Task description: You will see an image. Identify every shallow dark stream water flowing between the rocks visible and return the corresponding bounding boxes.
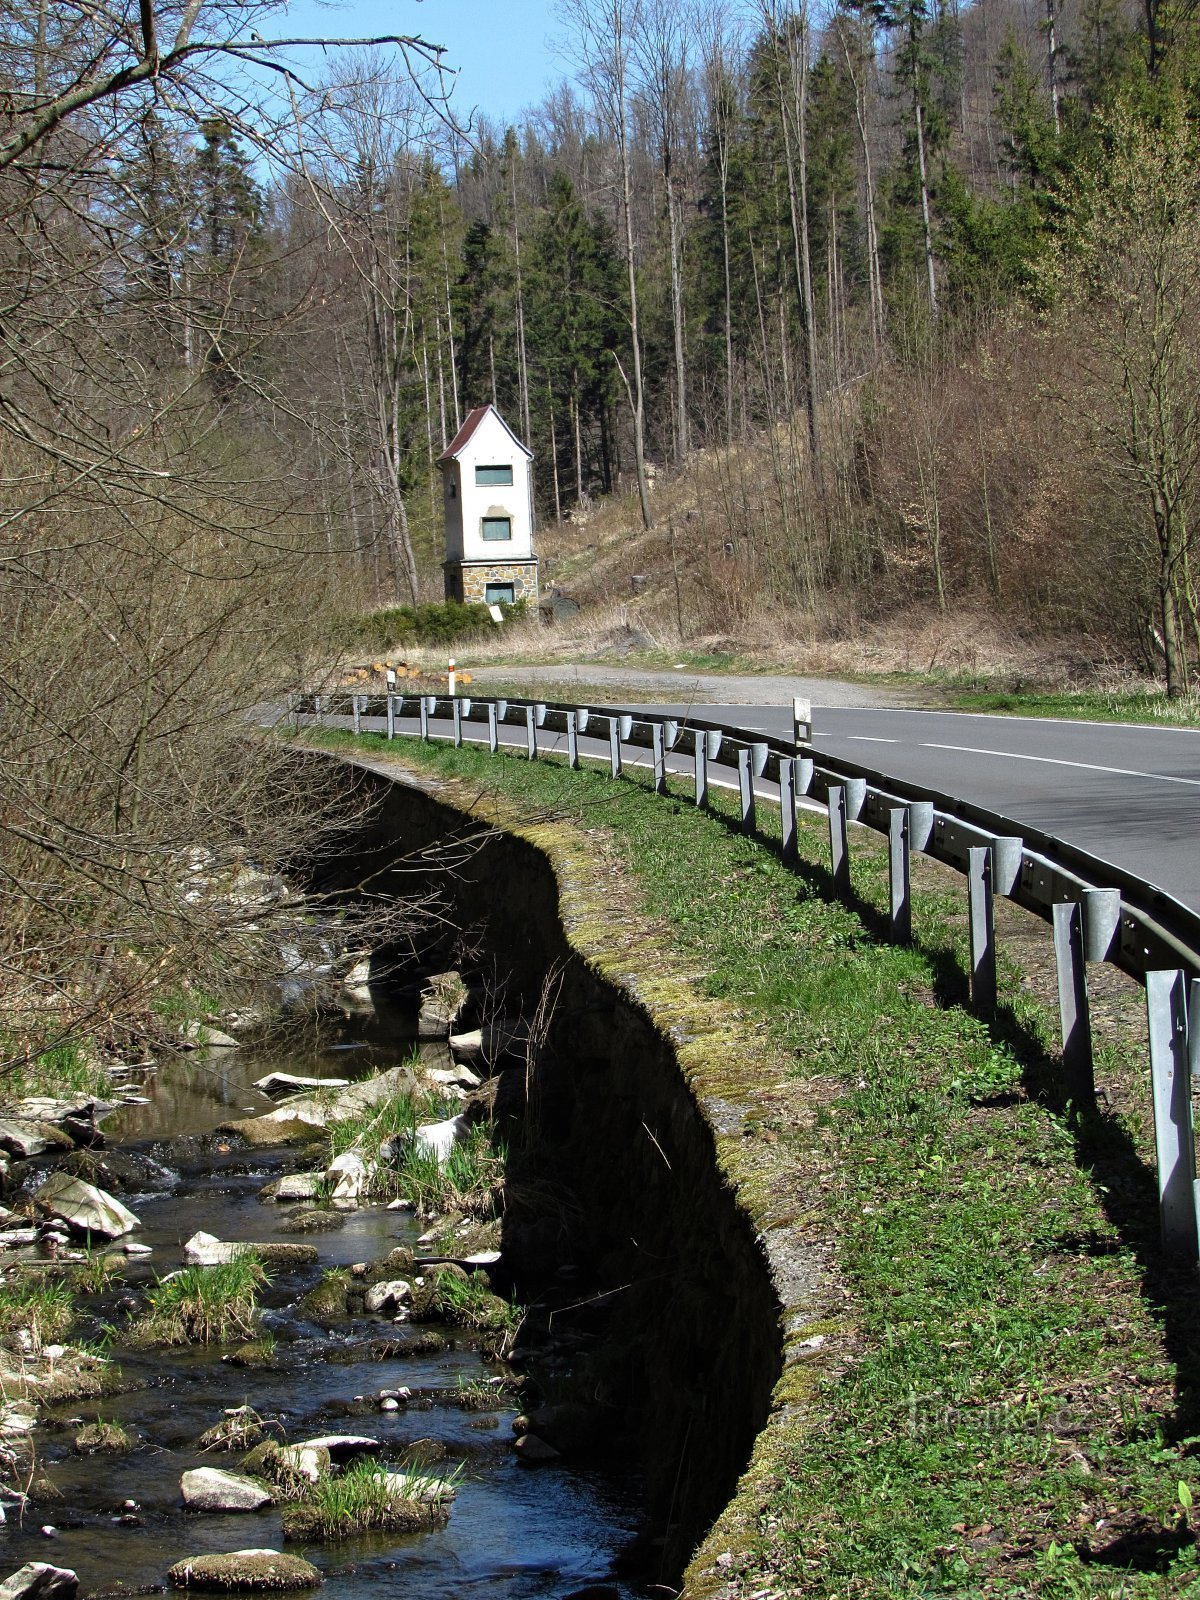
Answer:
[0,1013,649,1600]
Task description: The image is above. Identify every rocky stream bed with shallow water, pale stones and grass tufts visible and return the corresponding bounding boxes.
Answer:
[0,974,646,1600]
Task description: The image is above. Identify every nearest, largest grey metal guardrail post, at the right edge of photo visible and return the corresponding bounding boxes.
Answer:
[1146,970,1197,1261]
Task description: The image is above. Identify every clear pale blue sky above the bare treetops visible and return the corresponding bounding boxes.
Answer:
[277,0,568,123]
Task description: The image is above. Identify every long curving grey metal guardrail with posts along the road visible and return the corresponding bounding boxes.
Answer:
[290,694,1200,1261]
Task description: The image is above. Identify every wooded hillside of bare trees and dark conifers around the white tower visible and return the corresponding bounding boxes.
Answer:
[0,0,1200,1056]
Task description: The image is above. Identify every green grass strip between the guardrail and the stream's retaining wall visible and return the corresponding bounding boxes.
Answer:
[305,736,1200,1600]
